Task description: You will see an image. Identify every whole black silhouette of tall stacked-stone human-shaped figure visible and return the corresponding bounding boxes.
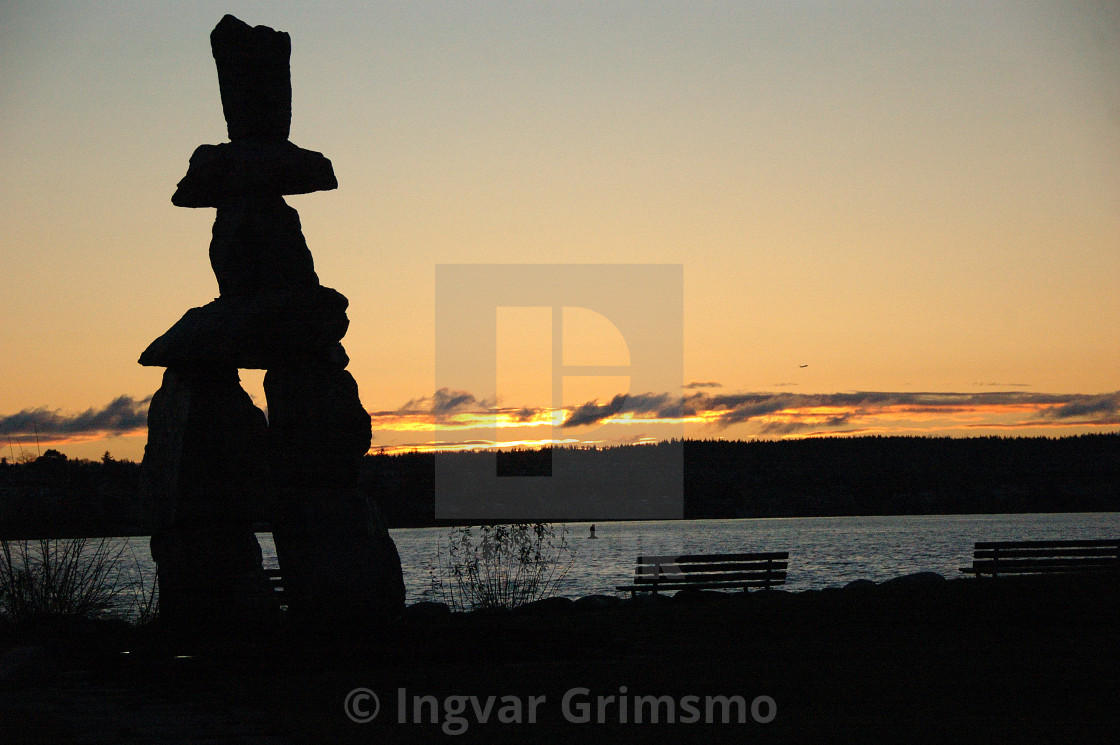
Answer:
[140,16,404,631]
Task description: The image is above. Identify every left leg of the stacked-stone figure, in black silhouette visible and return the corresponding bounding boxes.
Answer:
[141,367,280,632]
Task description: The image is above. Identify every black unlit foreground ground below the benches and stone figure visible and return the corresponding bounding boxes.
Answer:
[0,579,1120,744]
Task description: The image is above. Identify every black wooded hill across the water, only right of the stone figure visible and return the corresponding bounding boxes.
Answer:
[365,435,1120,527]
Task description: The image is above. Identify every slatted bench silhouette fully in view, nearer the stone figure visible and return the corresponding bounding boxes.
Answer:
[617,551,790,597]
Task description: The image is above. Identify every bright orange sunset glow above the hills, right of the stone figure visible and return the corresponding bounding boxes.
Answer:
[360,393,1120,453]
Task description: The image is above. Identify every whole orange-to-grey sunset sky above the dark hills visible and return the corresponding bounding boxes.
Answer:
[0,0,1120,459]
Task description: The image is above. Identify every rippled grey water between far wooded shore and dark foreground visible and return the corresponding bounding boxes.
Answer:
[115,512,1120,603]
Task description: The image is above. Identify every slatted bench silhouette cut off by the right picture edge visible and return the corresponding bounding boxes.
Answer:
[961,539,1120,577]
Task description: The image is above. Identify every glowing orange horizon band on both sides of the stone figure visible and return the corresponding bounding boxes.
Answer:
[0,391,1120,460]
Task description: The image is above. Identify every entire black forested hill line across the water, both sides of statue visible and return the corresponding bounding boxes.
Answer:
[0,435,1120,538]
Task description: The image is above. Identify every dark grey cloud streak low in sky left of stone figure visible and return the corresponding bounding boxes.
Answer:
[0,395,151,443]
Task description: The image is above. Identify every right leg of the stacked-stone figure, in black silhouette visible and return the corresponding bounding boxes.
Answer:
[264,364,404,632]
